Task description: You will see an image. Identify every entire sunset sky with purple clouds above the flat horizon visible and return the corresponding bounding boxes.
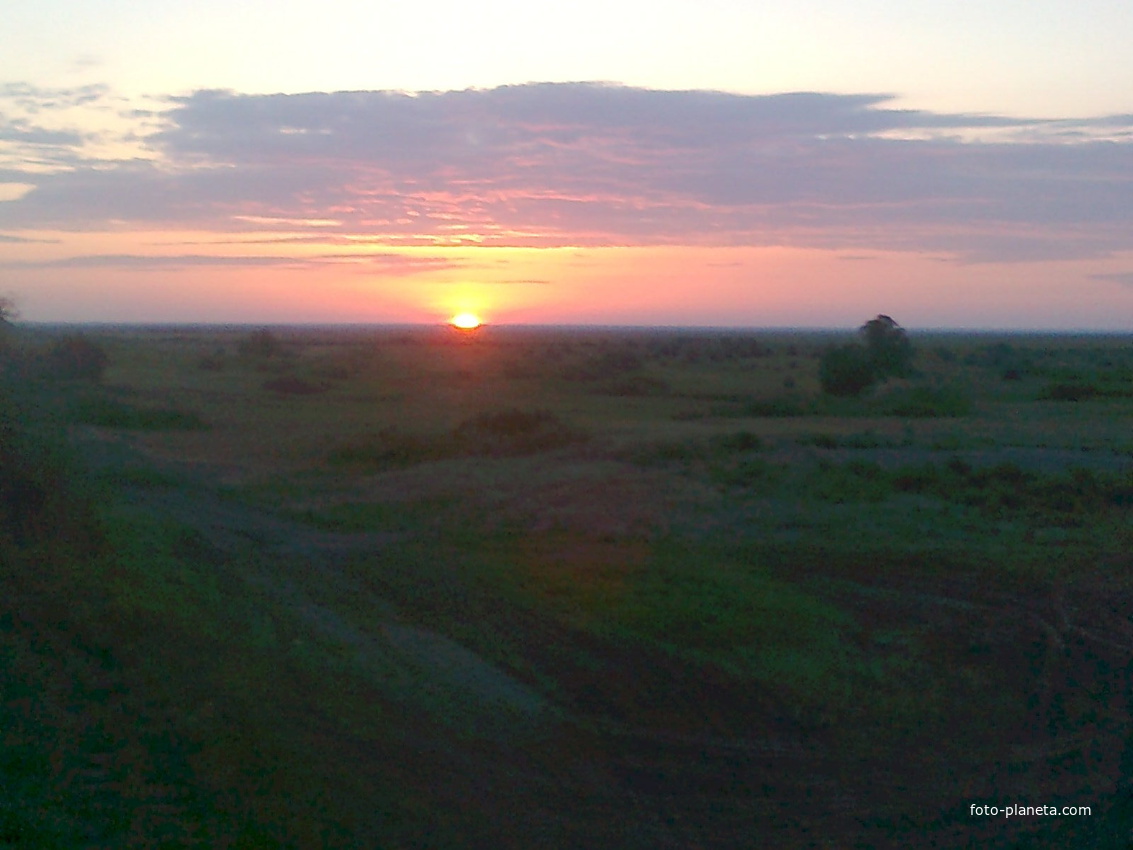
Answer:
[0,0,1133,331]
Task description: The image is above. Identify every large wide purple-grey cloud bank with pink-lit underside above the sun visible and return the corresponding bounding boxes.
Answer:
[0,83,1133,262]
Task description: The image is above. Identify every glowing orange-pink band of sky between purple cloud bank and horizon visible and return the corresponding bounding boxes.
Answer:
[8,232,1133,330]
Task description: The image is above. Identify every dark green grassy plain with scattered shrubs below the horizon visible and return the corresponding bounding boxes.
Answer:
[0,328,1133,848]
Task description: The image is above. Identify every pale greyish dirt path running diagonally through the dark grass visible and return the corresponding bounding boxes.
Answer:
[84,432,559,741]
